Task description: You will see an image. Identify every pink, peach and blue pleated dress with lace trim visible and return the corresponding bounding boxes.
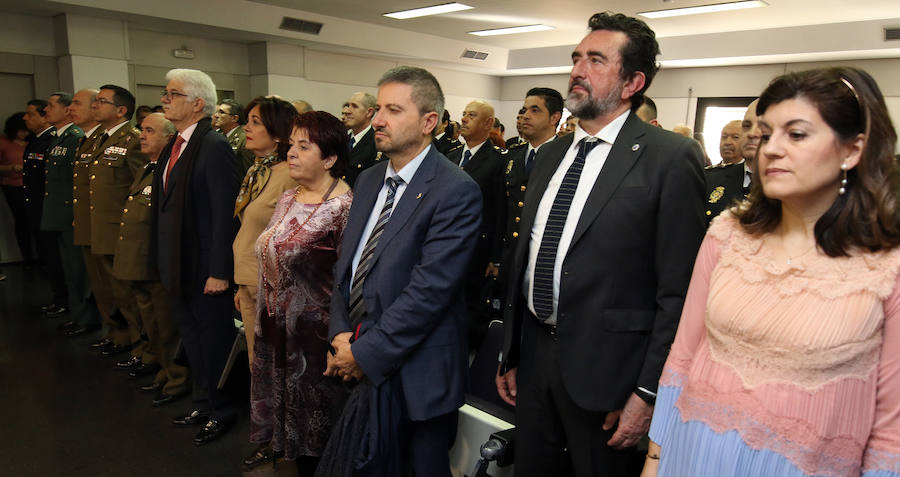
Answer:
[650,211,900,477]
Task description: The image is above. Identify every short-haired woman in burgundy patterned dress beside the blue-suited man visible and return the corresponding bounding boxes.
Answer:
[250,111,353,475]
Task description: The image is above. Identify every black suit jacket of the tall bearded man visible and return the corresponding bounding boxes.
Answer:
[501,114,705,411]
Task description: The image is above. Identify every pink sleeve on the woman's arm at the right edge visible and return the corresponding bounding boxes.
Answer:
[863,277,900,477]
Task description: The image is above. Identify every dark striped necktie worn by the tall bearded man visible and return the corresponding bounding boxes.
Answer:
[531,137,601,321]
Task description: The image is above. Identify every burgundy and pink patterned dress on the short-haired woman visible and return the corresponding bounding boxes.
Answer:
[250,190,353,460]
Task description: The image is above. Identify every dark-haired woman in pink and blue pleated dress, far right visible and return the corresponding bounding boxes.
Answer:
[644,68,900,477]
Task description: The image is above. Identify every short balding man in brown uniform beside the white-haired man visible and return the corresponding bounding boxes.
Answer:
[113,113,190,406]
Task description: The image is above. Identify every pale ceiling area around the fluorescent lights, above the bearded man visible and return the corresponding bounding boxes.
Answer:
[253,0,900,49]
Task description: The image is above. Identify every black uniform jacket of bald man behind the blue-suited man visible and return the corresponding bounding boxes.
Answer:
[447,140,506,266]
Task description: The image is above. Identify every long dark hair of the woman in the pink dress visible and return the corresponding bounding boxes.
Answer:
[738,67,900,257]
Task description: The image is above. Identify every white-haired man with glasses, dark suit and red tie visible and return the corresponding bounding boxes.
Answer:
[151,69,241,446]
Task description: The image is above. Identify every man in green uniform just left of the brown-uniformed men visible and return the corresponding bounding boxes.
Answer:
[41,92,100,330]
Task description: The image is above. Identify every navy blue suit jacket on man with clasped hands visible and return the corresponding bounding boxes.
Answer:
[329,146,481,421]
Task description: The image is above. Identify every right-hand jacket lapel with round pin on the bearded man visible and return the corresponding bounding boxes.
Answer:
[569,114,645,249]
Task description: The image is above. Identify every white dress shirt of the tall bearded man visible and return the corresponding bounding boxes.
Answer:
[522,111,630,324]
